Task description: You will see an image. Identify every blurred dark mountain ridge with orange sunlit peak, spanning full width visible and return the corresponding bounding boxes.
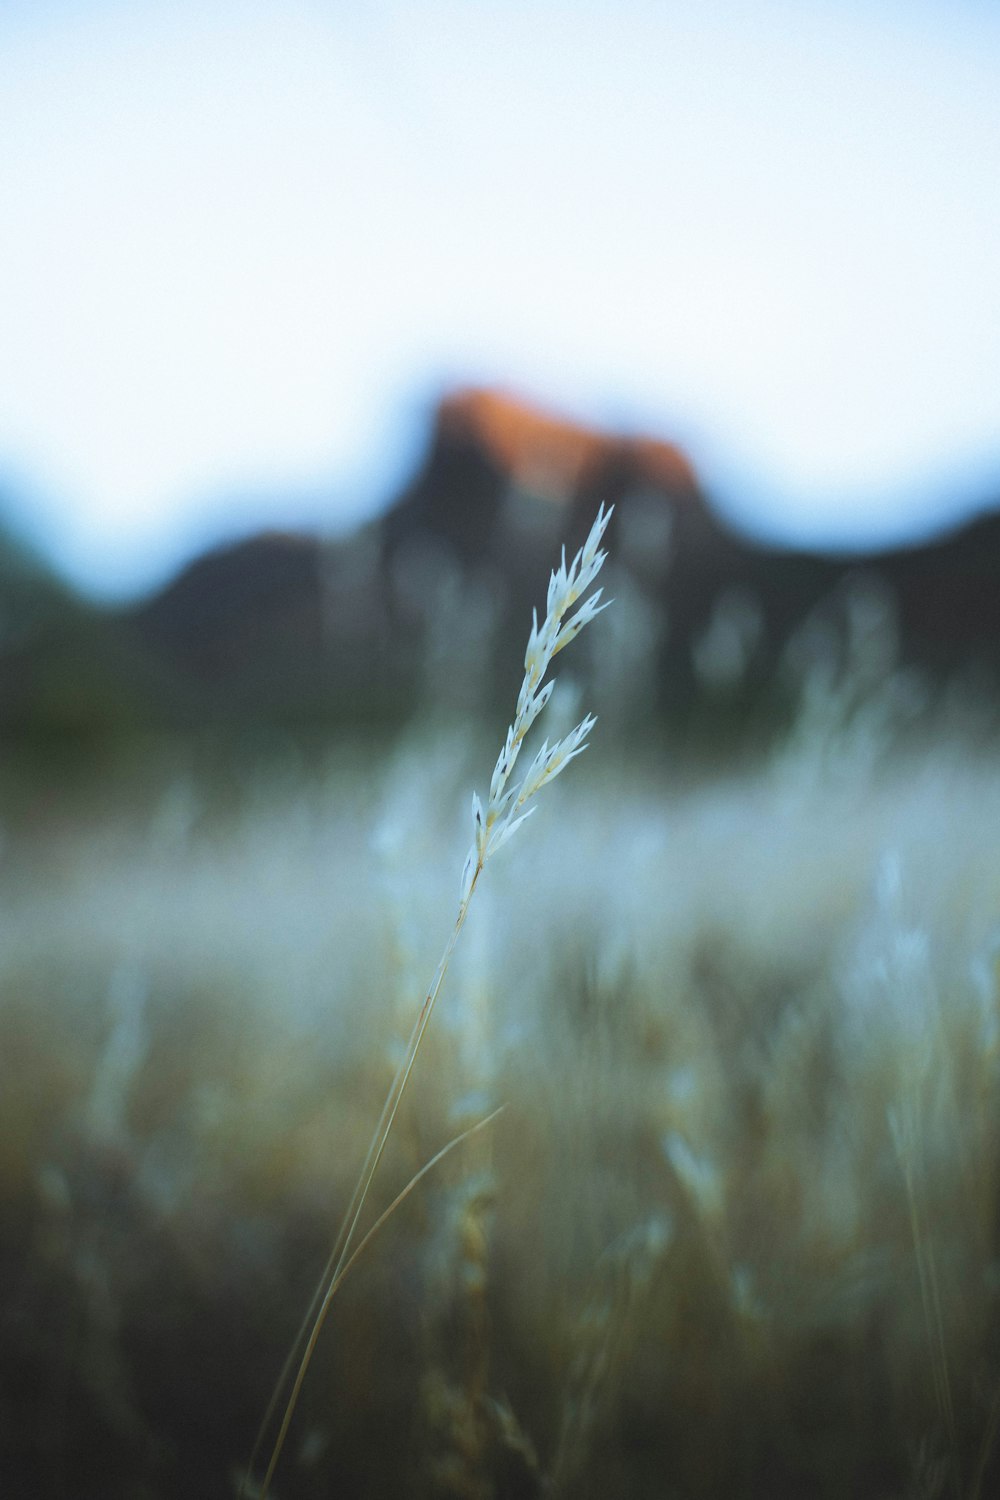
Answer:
[0,390,1000,737]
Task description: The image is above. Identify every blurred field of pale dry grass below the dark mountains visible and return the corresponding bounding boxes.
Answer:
[0,552,1000,1500]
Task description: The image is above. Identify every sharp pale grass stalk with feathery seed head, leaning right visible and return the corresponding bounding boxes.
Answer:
[241,506,615,1500]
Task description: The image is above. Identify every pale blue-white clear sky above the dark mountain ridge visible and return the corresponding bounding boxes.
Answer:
[0,0,1000,597]
